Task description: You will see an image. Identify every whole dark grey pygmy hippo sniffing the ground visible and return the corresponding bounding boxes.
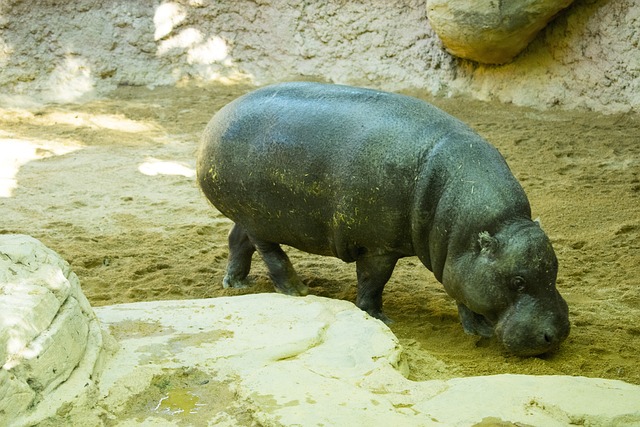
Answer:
[197,83,569,356]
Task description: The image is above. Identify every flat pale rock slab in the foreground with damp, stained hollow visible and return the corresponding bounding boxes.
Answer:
[95,294,640,426]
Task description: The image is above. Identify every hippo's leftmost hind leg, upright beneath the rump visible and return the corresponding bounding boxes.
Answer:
[222,224,256,288]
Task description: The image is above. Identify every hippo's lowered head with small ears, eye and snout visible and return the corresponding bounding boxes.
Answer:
[443,220,569,356]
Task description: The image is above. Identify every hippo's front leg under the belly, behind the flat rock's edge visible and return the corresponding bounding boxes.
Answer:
[356,256,398,324]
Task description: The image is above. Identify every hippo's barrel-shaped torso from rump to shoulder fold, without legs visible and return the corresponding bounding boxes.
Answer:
[197,83,510,261]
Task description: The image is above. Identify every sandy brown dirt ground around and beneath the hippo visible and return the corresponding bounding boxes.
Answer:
[0,85,640,384]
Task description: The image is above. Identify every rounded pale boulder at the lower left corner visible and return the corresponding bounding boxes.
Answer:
[0,235,112,425]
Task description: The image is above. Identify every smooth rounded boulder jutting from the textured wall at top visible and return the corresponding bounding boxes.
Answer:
[427,0,573,64]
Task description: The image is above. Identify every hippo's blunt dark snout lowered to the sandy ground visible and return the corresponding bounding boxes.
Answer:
[495,294,570,357]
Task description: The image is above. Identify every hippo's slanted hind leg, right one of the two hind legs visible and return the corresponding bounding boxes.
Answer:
[252,239,309,296]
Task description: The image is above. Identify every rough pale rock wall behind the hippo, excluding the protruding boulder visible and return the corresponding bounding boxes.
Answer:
[0,0,640,112]
